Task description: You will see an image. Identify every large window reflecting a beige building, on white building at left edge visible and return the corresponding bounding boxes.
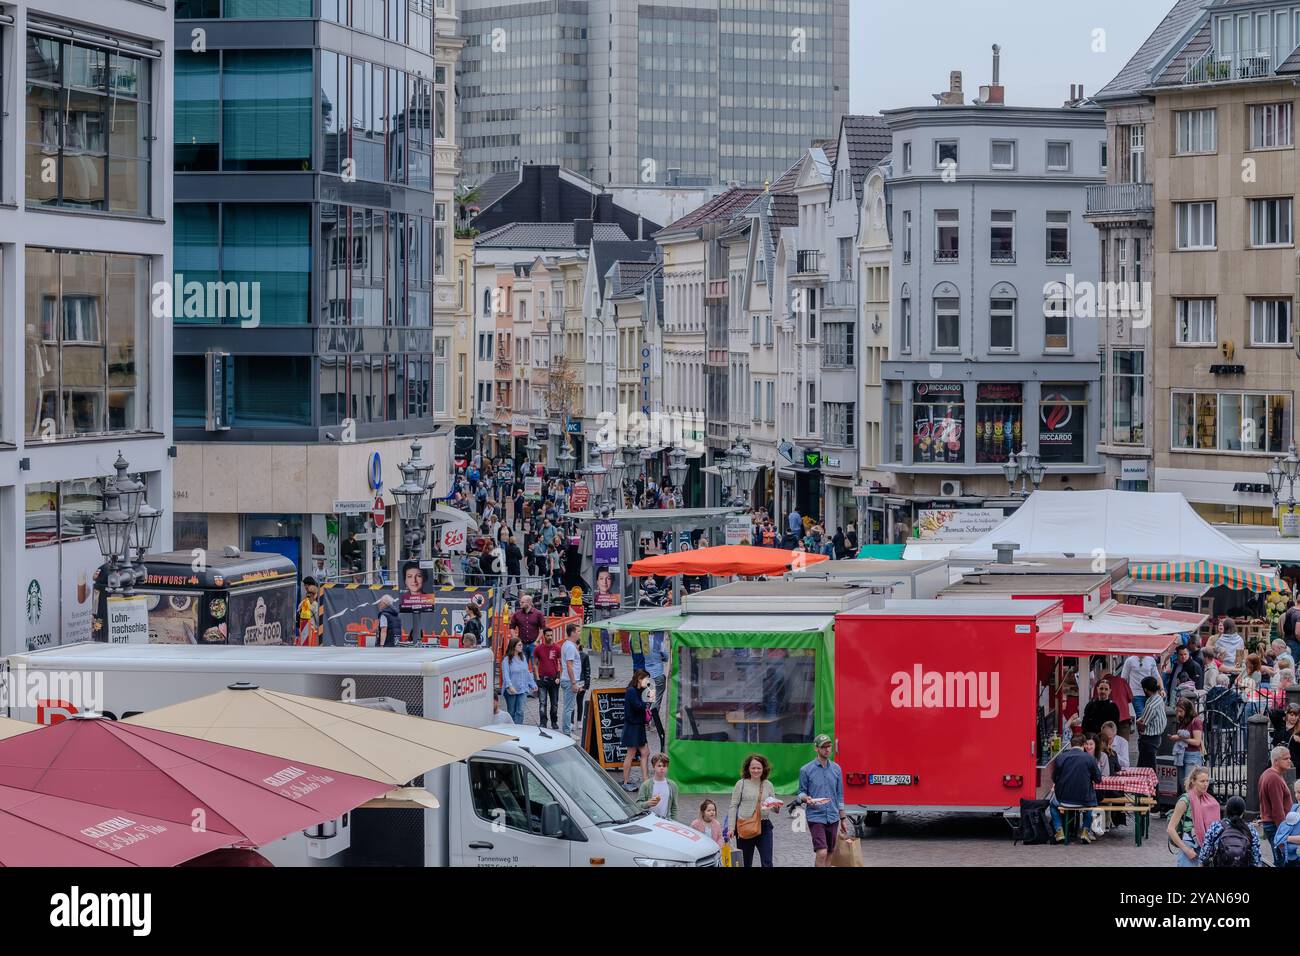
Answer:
[23,248,151,438]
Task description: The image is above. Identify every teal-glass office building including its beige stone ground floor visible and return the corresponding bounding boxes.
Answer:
[173,0,455,574]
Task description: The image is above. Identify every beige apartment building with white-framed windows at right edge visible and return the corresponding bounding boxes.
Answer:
[1145,4,1300,524]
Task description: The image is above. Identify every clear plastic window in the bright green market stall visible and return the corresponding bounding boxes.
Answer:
[676,646,816,744]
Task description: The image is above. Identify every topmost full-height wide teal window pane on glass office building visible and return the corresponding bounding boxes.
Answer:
[221,49,312,172]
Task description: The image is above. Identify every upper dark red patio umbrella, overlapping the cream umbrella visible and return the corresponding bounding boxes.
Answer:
[0,718,391,842]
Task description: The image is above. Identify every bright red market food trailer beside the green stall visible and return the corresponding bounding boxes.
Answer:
[835,597,1195,826]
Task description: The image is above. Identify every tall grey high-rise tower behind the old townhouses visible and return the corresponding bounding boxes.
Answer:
[459,0,849,186]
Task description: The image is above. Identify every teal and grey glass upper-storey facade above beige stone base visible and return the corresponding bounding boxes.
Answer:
[173,0,450,441]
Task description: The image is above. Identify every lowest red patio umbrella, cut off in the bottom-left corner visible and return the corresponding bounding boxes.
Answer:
[0,787,230,866]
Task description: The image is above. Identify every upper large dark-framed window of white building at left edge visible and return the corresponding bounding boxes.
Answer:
[25,34,153,215]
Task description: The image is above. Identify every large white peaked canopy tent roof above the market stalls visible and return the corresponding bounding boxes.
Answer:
[950,490,1260,570]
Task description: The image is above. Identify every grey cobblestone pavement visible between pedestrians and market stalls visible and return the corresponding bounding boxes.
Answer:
[512,653,1174,866]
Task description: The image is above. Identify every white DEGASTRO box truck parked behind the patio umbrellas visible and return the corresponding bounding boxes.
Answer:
[3,643,720,866]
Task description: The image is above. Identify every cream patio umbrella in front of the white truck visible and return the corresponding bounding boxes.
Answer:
[126,684,514,809]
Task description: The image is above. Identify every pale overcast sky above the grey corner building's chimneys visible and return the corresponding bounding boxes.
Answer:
[849,0,1174,113]
